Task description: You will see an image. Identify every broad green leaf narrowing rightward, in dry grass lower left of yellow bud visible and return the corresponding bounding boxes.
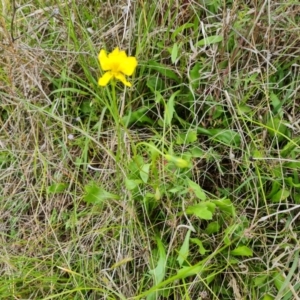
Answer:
[83,182,120,204]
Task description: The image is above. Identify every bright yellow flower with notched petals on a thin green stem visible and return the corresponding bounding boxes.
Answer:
[98,47,137,86]
